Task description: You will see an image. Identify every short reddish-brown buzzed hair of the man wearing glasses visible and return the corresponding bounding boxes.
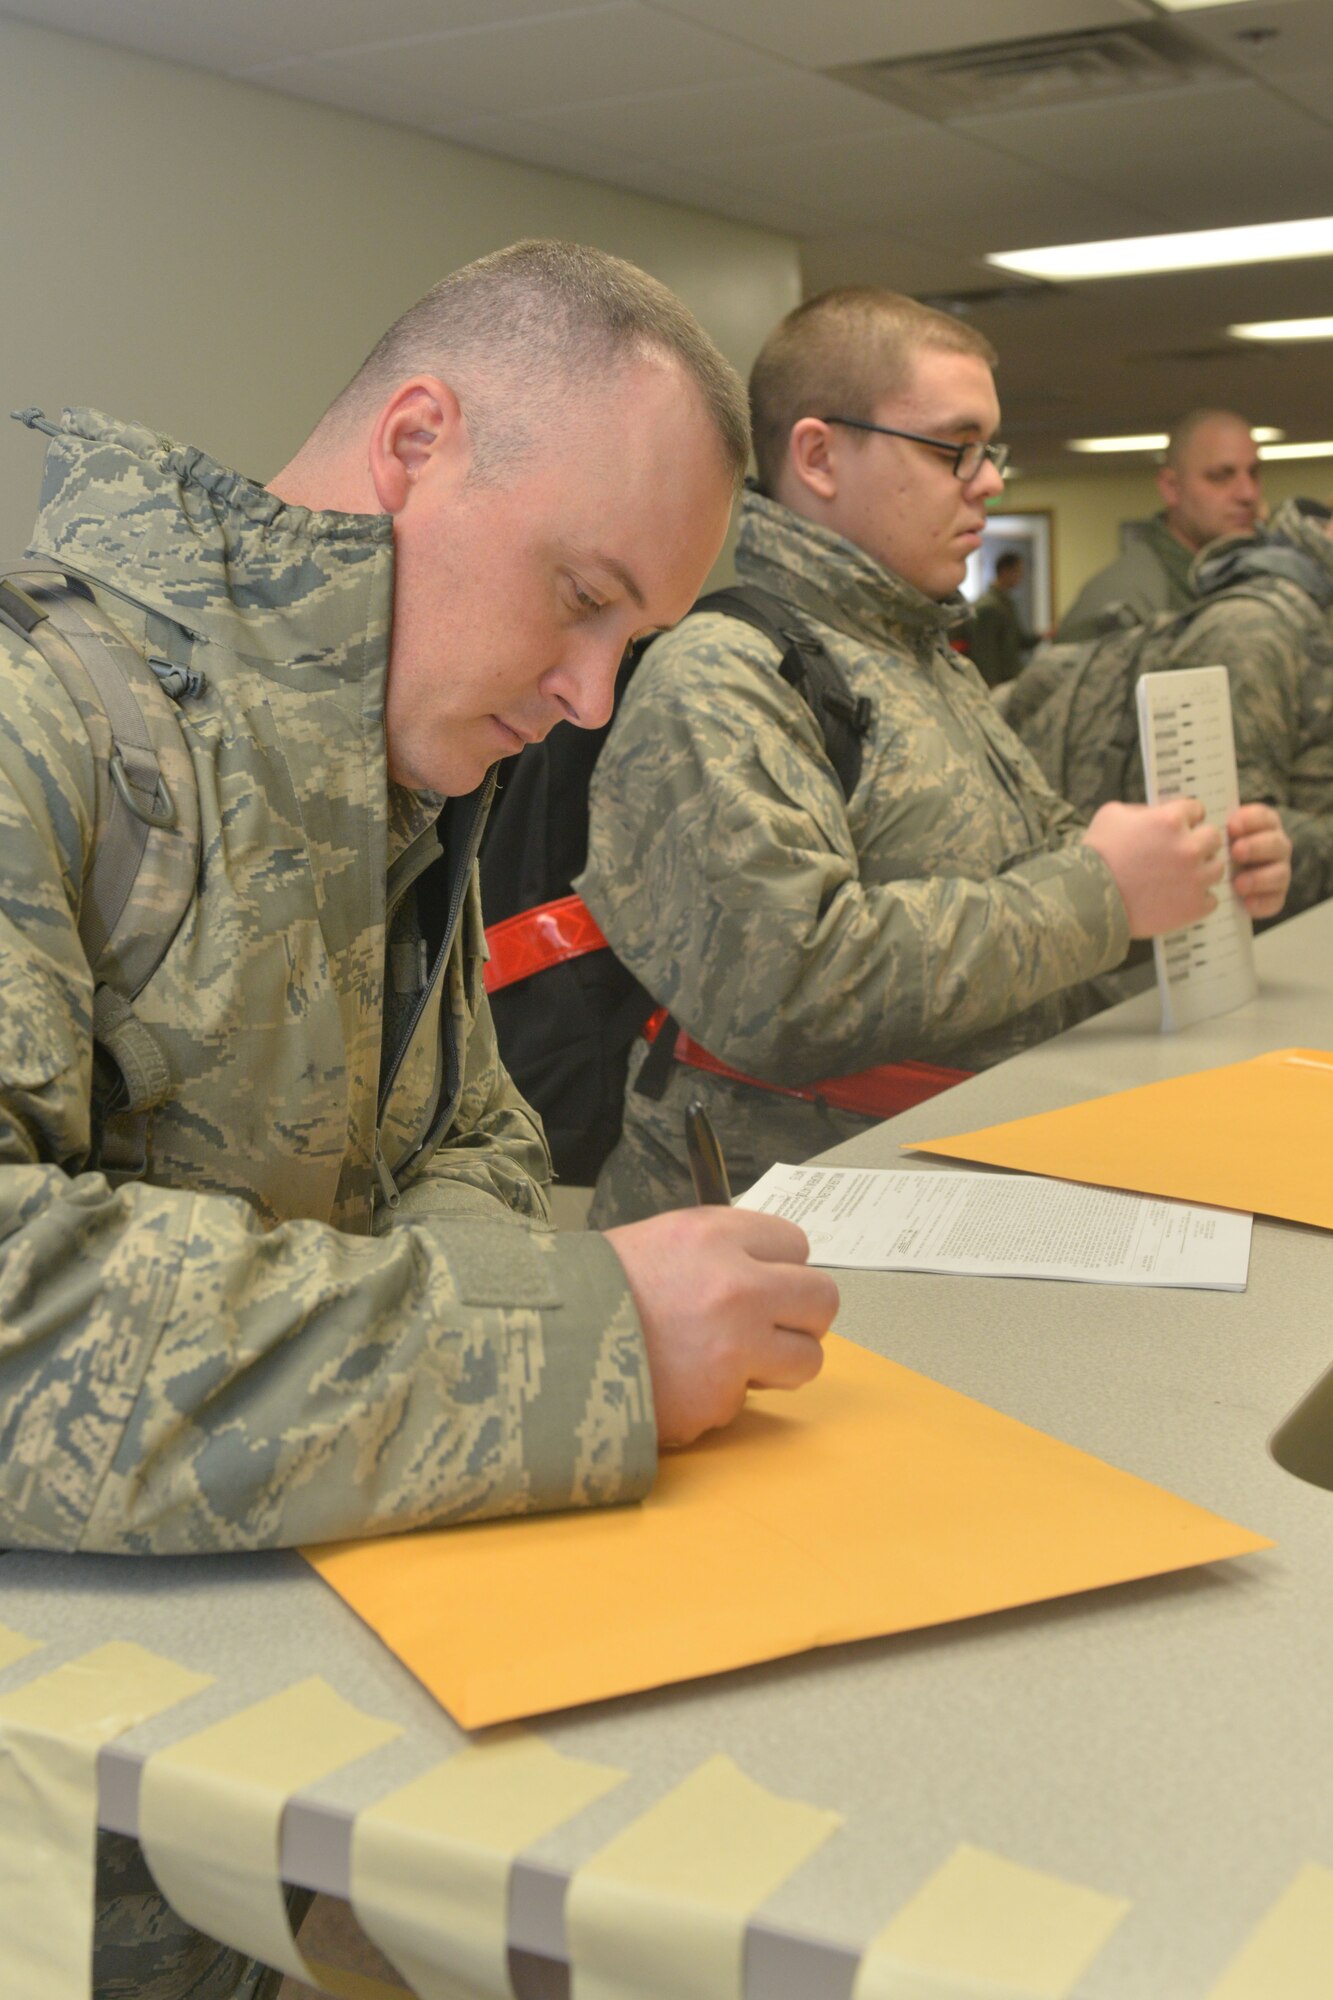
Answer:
[751,284,999,496]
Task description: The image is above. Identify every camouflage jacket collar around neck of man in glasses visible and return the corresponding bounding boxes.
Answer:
[737,486,971,648]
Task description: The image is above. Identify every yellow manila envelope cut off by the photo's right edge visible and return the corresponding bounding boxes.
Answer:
[903,1048,1333,1230]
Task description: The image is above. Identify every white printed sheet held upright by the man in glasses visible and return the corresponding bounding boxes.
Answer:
[1139,666,1259,1032]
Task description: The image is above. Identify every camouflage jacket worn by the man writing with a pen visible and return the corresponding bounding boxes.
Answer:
[0,412,654,1554]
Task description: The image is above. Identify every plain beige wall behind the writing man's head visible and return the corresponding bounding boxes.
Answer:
[0,20,801,550]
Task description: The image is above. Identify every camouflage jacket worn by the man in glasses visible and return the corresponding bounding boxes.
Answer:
[578,494,1129,1220]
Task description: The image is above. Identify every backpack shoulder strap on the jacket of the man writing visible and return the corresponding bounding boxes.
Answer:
[0,558,200,1016]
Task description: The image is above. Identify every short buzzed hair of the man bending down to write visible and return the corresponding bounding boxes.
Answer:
[320,238,751,488]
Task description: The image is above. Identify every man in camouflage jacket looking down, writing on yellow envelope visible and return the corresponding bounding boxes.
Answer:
[0,244,837,2000]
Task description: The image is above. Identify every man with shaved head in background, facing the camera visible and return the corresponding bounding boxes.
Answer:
[1055,410,1263,640]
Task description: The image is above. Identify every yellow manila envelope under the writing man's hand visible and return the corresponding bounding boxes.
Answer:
[302,1334,1271,1728]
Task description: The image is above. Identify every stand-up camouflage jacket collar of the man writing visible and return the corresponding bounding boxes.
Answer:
[20,410,392,684]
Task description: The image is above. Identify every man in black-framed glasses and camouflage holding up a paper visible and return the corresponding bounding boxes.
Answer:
[578,288,1289,1224]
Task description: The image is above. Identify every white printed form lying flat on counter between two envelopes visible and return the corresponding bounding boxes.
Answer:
[737,1166,1253,1292]
